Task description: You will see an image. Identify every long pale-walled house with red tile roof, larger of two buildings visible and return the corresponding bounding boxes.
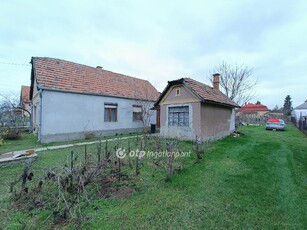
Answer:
[30,57,159,143]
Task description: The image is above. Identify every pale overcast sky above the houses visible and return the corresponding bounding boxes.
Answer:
[0,0,307,108]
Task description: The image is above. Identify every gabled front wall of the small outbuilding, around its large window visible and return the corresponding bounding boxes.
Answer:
[160,86,201,139]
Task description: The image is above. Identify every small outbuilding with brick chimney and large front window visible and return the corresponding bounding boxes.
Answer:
[155,74,239,140]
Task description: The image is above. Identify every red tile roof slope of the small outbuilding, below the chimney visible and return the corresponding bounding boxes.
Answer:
[183,78,239,107]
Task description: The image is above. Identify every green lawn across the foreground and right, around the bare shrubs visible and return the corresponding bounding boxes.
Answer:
[0,126,307,229]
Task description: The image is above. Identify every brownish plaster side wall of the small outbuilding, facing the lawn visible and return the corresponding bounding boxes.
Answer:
[201,103,235,140]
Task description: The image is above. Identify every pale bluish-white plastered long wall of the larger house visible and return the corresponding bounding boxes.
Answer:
[40,90,156,143]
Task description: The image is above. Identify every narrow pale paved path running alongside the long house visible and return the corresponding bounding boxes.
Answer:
[0,136,142,164]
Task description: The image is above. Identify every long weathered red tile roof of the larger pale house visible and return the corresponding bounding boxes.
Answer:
[32,57,160,101]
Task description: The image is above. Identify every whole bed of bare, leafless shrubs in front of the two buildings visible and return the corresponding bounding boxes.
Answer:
[10,135,201,225]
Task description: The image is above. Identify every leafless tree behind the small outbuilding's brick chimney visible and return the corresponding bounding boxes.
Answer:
[210,61,258,105]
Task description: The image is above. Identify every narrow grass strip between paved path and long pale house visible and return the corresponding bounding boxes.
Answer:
[0,133,144,154]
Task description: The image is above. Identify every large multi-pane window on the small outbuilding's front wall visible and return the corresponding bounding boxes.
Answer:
[168,106,189,127]
